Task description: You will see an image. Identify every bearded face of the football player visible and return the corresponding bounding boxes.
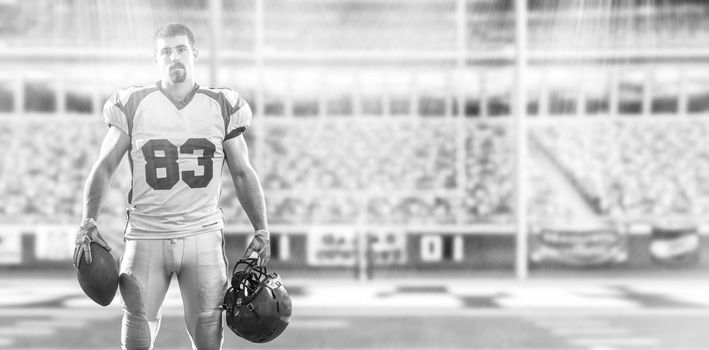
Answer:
[155,35,197,84]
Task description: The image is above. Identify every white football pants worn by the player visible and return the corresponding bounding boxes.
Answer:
[119,230,228,350]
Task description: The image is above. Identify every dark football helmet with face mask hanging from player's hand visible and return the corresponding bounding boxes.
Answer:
[222,259,293,343]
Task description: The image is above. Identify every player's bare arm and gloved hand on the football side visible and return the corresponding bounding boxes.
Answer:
[74,126,130,267]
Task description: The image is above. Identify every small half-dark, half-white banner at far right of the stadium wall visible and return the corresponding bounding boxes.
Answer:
[649,226,700,266]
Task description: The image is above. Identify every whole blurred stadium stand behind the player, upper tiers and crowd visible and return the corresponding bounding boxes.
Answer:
[0,0,709,274]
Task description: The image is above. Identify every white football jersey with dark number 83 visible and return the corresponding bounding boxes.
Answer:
[103,82,251,239]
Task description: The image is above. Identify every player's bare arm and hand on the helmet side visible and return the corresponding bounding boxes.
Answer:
[222,135,271,266]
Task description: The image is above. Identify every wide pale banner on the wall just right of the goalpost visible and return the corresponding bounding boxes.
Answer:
[530,228,628,266]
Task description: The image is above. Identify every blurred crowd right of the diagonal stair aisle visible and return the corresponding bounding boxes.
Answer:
[534,119,709,220]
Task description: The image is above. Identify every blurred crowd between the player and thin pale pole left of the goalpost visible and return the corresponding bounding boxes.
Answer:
[231,118,459,224]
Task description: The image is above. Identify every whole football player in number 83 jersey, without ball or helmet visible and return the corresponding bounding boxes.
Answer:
[74,24,270,349]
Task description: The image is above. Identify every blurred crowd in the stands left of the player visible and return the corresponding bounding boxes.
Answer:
[0,121,126,223]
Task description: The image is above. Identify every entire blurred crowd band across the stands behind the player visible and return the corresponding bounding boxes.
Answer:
[0,118,709,225]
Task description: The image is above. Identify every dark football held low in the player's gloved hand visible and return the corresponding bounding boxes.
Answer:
[76,242,118,306]
